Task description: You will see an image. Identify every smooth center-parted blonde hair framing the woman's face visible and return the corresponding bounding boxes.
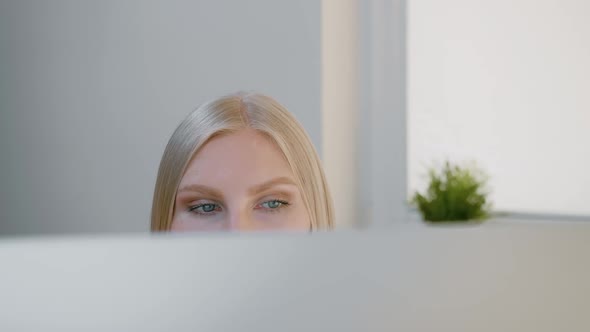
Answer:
[151,93,334,231]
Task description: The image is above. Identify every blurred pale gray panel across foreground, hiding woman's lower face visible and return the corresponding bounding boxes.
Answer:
[0,223,590,332]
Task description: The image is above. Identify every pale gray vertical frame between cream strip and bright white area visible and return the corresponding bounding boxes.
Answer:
[358,0,411,227]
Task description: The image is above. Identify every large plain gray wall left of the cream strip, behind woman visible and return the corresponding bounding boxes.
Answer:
[0,0,321,235]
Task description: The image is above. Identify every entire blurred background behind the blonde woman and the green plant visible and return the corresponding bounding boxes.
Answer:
[0,0,590,236]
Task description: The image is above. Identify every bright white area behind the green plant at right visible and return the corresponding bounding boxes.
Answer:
[408,0,590,215]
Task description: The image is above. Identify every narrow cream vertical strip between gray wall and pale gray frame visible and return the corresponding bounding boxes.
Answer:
[321,0,359,227]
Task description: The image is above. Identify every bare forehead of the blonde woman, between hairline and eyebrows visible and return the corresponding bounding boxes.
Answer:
[180,129,293,188]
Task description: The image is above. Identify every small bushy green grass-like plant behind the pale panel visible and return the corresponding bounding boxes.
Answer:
[411,161,491,222]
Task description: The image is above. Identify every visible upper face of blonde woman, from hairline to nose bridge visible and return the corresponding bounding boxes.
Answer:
[172,129,310,231]
